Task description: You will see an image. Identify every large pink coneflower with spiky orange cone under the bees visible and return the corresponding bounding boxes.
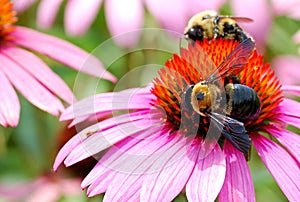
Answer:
[54,39,300,201]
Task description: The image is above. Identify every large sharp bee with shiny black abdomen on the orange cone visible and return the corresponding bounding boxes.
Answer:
[183,39,261,153]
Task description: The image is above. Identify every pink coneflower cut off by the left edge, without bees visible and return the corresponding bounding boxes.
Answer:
[0,0,115,127]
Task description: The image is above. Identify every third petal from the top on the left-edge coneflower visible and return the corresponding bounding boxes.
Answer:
[0,52,64,116]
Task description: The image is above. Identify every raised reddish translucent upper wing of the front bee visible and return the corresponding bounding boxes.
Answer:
[206,38,255,82]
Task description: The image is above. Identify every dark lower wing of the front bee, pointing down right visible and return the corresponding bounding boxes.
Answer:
[210,112,251,153]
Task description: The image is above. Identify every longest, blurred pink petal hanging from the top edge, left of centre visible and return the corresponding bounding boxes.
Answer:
[105,0,144,47]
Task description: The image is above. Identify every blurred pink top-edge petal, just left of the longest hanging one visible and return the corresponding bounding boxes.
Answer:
[65,0,102,35]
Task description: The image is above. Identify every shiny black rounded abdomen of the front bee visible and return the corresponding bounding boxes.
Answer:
[226,84,261,121]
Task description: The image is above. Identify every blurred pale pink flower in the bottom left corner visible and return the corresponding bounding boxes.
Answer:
[0,176,81,202]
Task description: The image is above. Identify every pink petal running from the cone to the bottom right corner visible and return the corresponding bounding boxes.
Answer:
[251,134,300,201]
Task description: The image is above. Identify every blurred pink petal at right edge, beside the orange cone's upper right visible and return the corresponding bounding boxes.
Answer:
[272,55,300,85]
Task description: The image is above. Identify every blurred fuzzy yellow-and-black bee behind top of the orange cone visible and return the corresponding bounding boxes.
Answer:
[184,10,253,42]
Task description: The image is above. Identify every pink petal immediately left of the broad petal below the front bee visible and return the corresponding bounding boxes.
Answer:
[141,137,200,201]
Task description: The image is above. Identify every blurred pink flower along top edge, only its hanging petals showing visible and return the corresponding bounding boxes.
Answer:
[15,0,226,47]
